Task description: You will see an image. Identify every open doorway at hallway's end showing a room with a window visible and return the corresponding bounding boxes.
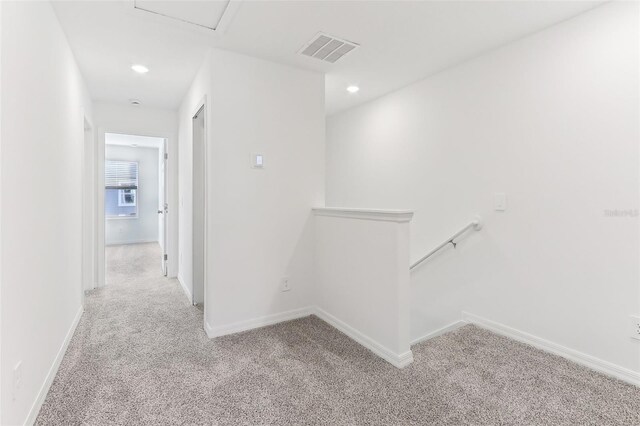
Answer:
[104,133,168,285]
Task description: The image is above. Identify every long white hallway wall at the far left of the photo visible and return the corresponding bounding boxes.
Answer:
[0,2,91,425]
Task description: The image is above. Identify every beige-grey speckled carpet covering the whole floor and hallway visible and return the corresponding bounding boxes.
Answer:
[37,244,640,425]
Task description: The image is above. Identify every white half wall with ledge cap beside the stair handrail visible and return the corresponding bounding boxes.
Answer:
[314,208,413,367]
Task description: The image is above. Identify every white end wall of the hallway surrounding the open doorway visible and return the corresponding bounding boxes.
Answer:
[93,102,178,285]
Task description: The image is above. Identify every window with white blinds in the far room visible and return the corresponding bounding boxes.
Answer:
[104,160,138,218]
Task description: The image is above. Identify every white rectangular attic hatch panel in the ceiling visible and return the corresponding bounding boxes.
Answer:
[133,0,239,31]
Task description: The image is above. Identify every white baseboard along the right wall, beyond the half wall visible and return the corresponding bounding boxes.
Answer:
[462,312,640,386]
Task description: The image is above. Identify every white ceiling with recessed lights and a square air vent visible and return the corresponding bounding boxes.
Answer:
[54,0,602,114]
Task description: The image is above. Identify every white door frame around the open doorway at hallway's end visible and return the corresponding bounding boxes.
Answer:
[96,126,178,288]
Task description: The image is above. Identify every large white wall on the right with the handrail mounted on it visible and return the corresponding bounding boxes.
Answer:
[327,3,640,372]
